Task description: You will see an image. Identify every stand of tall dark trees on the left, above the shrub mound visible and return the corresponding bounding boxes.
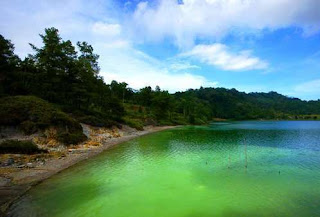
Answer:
[0,28,124,125]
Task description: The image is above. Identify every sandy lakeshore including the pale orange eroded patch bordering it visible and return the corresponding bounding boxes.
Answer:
[0,125,173,216]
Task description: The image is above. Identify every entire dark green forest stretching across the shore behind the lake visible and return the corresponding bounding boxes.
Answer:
[0,28,320,142]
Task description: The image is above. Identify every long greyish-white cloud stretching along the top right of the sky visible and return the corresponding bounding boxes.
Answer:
[132,0,320,47]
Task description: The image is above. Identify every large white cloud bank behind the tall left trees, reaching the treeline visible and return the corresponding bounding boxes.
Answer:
[0,0,216,92]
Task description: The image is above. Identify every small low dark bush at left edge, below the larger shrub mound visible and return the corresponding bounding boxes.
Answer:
[0,140,47,154]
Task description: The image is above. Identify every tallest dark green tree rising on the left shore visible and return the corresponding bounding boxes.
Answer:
[30,28,78,103]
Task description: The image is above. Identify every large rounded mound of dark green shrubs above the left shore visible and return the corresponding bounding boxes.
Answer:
[0,96,84,144]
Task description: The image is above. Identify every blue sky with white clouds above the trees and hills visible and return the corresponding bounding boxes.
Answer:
[0,0,320,100]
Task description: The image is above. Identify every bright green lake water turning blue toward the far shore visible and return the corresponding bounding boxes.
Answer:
[9,121,320,217]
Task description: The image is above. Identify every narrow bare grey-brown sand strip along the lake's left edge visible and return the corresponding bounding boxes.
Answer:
[0,126,174,216]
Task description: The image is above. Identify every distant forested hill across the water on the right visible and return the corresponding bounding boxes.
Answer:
[175,88,320,119]
